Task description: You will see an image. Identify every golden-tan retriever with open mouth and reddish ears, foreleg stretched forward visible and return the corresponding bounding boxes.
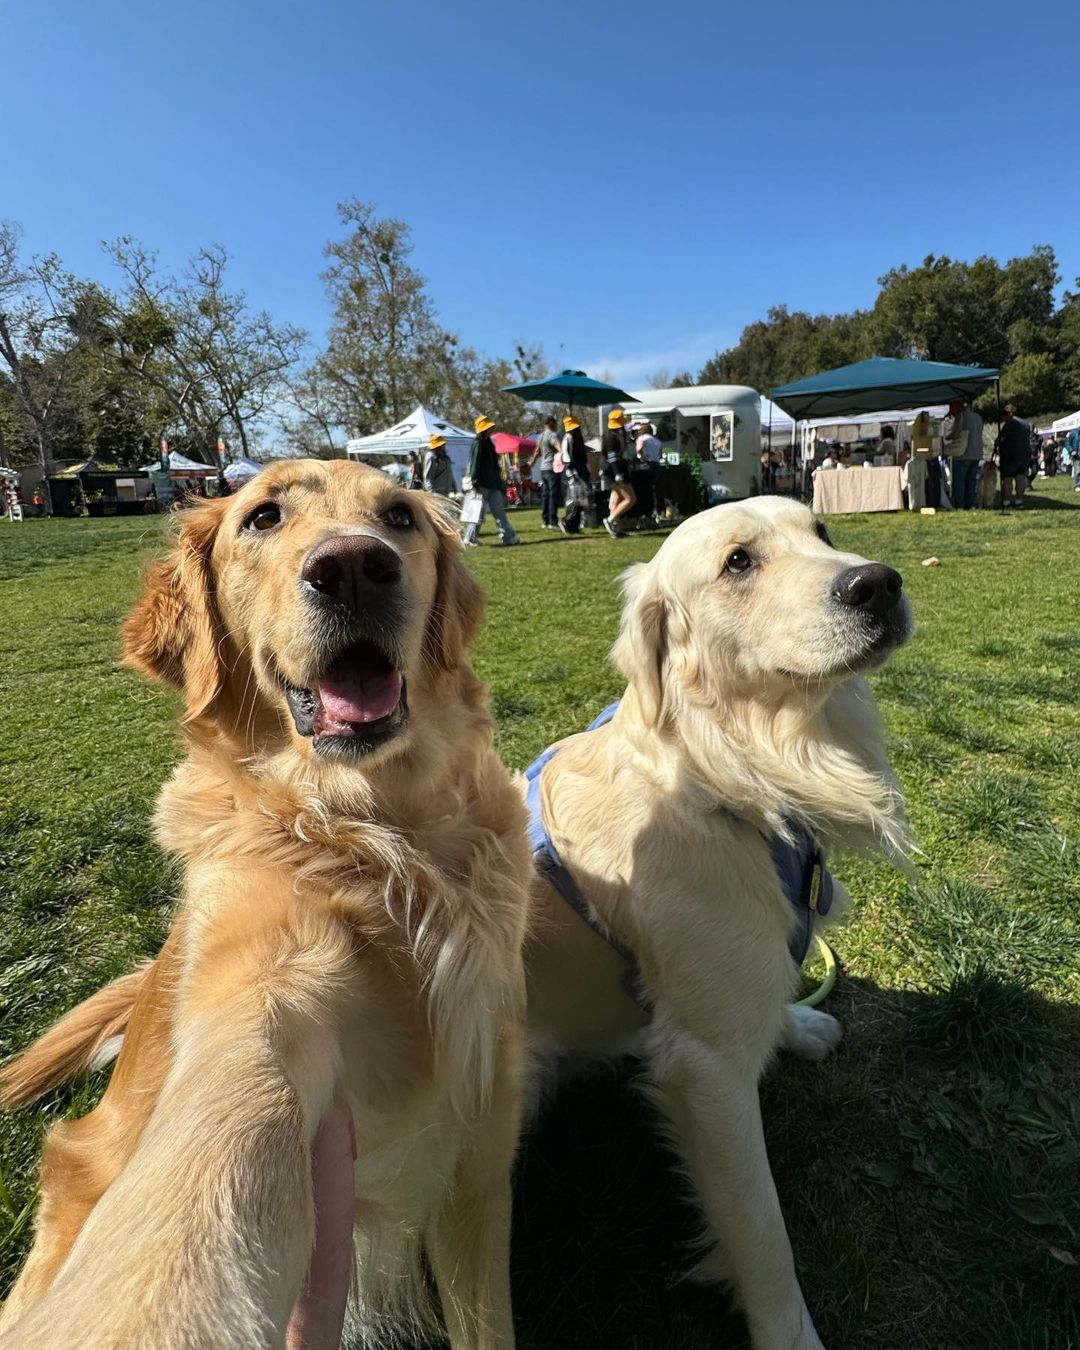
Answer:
[0,460,528,1350]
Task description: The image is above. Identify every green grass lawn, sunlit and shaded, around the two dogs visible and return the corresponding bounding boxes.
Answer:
[0,479,1080,1350]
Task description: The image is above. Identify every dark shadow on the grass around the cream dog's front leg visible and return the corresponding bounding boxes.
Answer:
[480,968,1080,1350]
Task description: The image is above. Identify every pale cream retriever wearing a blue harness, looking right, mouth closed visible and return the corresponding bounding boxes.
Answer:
[527,497,911,1350]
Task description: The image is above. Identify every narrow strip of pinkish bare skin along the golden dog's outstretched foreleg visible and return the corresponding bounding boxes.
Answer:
[285,1098,356,1350]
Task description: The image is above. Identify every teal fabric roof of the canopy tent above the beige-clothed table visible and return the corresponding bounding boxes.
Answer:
[770,356,999,419]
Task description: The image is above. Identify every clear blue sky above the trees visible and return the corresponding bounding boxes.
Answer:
[0,0,1080,385]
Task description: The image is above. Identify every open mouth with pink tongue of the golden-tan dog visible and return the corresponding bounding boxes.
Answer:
[284,641,408,753]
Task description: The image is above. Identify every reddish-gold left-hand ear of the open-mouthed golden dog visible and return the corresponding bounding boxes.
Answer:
[123,502,225,721]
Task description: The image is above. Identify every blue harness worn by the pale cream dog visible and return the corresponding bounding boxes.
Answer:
[525,702,833,1007]
